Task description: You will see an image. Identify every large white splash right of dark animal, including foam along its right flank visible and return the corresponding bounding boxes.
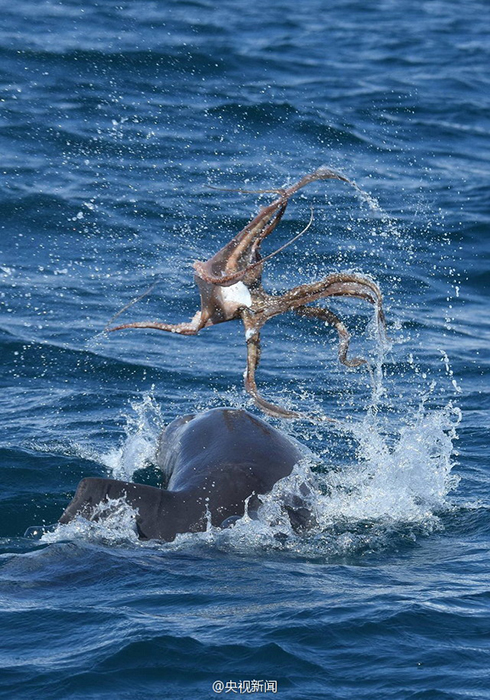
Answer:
[197,396,461,556]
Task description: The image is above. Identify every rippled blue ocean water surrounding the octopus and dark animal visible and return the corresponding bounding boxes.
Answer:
[0,0,490,700]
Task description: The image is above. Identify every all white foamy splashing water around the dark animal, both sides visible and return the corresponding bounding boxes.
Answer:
[41,382,461,557]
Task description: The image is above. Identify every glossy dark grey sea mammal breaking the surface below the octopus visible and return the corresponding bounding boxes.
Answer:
[59,408,308,542]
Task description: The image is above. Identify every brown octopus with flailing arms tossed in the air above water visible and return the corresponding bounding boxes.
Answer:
[106,167,385,420]
